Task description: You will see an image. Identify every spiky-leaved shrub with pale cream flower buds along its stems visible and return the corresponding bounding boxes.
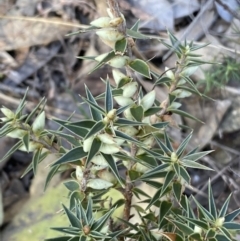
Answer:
[0,0,240,241]
